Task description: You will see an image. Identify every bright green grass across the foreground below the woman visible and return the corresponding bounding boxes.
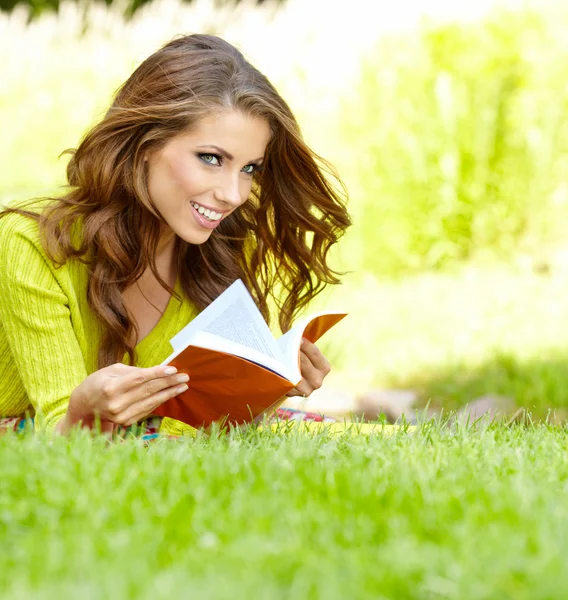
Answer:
[0,424,568,600]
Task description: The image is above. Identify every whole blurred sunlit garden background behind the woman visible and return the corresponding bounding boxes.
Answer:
[0,0,568,411]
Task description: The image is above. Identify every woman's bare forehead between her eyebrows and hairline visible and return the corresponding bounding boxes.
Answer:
[175,110,270,161]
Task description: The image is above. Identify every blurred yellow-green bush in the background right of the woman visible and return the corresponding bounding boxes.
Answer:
[341,10,568,273]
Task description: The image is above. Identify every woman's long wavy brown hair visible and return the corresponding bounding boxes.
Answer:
[3,35,350,368]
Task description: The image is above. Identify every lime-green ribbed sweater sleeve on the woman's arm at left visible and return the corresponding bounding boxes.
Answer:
[0,215,87,430]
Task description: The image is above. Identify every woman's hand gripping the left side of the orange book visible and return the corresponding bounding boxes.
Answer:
[56,363,189,433]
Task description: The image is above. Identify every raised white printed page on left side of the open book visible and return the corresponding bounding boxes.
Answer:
[167,279,283,360]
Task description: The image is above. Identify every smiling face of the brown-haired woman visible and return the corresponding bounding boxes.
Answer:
[147,110,270,244]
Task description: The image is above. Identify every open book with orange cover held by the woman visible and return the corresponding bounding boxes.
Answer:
[153,279,346,427]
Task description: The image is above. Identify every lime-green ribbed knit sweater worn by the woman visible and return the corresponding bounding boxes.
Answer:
[0,209,196,433]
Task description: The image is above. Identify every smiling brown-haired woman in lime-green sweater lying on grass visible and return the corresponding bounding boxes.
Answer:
[0,35,350,434]
